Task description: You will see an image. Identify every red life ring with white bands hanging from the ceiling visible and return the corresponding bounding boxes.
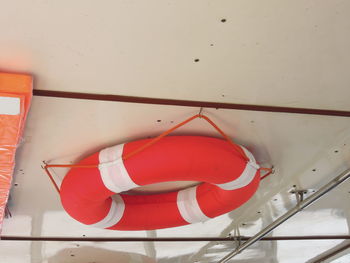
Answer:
[60,136,260,230]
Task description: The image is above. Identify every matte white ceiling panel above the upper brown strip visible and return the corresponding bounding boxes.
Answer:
[0,0,350,110]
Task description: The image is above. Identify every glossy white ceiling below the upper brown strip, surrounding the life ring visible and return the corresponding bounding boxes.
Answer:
[0,97,350,263]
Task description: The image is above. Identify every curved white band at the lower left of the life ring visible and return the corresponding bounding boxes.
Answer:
[89,195,125,228]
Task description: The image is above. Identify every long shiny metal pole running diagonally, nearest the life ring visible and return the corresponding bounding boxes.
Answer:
[219,170,350,263]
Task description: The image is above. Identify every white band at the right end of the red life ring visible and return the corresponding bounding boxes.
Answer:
[216,146,260,190]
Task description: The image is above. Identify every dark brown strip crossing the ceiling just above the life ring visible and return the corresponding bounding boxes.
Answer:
[33,90,350,117]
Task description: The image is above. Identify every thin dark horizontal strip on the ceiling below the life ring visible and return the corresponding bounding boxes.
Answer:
[0,235,350,242]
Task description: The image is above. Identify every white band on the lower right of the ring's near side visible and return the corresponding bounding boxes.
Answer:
[177,186,210,224]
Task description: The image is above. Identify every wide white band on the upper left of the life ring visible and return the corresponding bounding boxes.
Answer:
[98,144,139,193]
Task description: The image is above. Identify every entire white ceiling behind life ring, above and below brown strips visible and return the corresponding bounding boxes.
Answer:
[0,0,350,263]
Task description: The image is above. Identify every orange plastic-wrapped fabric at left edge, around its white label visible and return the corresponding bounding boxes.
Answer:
[0,73,33,231]
